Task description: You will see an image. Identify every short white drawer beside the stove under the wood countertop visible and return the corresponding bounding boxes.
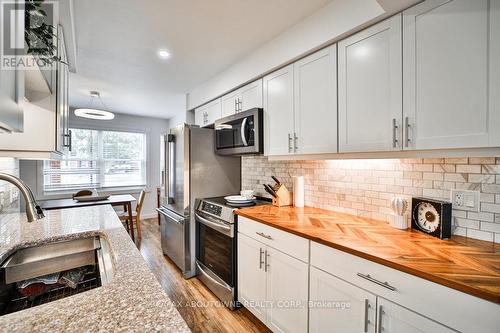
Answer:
[238,216,309,262]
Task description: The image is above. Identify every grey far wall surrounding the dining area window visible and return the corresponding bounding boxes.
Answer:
[20,110,169,218]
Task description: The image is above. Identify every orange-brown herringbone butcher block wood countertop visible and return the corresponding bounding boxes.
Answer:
[236,205,500,304]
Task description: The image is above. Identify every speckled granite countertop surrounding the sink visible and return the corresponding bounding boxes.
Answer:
[0,206,190,332]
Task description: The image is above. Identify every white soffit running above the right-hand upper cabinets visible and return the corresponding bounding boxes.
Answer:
[187,0,419,109]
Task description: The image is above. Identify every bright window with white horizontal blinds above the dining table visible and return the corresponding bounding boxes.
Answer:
[43,128,146,192]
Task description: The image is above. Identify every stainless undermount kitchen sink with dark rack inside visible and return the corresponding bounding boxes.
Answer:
[0,237,114,315]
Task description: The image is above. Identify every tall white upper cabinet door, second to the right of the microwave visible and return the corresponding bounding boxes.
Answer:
[294,45,337,154]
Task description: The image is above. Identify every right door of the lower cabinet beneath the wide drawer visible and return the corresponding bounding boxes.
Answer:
[377,297,456,333]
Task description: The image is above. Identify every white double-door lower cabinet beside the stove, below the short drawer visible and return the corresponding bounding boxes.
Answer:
[238,233,309,332]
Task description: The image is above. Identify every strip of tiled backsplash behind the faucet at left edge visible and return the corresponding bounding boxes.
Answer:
[0,157,19,215]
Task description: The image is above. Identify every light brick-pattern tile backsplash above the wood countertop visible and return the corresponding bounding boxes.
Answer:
[242,157,500,243]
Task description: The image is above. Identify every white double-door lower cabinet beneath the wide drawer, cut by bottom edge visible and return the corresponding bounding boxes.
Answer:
[309,266,455,333]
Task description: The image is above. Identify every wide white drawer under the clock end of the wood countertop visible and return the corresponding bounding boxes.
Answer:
[311,242,500,332]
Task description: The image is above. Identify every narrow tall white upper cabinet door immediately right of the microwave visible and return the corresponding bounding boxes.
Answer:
[263,65,294,155]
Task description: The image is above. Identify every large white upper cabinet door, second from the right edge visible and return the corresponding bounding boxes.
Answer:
[338,15,402,152]
